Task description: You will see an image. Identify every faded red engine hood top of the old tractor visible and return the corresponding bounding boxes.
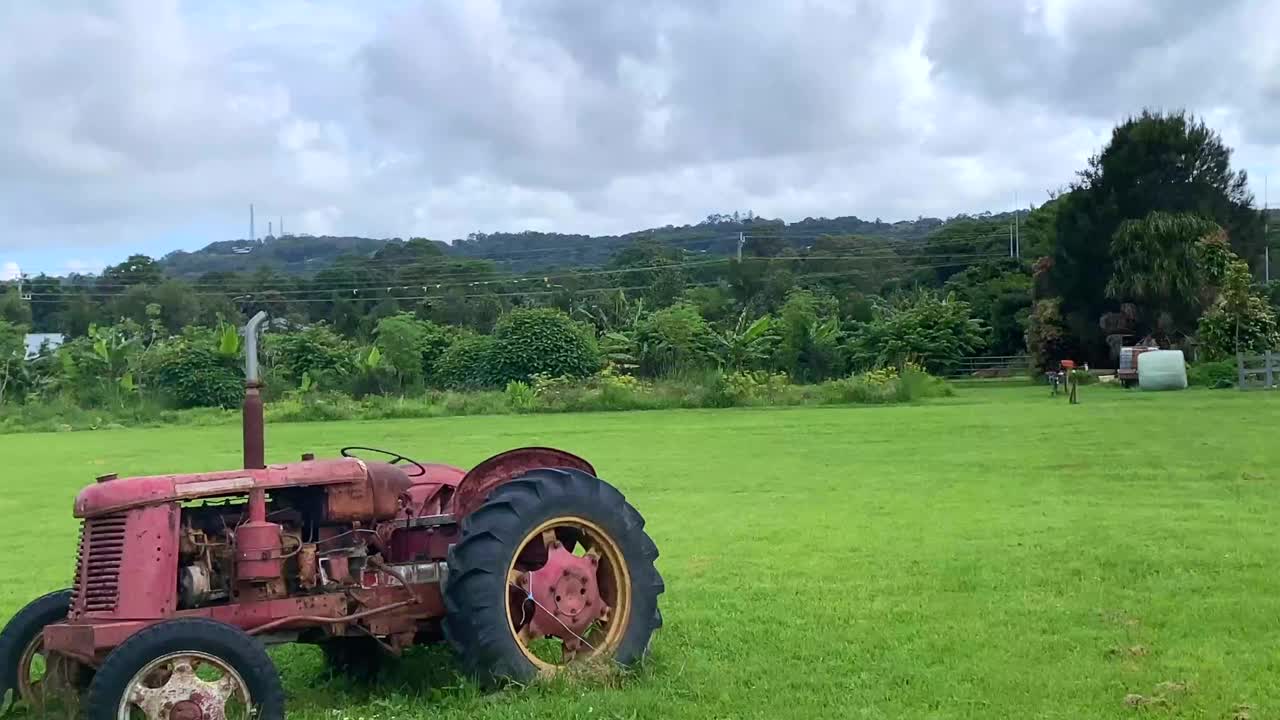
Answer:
[74,457,369,518]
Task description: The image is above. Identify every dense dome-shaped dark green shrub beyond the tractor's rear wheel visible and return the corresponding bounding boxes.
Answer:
[488,307,600,386]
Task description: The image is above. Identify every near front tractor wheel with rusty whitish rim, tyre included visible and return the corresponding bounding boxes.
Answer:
[84,618,284,720]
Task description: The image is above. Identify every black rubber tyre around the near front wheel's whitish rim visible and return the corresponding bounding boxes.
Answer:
[84,618,284,720]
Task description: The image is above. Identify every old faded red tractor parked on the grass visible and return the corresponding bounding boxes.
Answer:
[0,313,663,720]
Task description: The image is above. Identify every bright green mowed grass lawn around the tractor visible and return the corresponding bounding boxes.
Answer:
[0,387,1280,720]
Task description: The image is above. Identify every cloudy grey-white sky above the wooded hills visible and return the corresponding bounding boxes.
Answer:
[0,0,1280,273]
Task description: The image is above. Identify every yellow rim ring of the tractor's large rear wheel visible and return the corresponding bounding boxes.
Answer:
[507,515,631,674]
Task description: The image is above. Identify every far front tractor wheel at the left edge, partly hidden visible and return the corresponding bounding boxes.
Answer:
[0,591,88,710]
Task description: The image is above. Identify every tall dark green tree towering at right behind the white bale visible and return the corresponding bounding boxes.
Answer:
[1048,111,1262,364]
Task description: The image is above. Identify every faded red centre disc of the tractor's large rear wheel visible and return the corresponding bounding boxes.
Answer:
[525,543,608,650]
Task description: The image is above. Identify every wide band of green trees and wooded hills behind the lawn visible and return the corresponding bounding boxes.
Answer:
[0,111,1280,422]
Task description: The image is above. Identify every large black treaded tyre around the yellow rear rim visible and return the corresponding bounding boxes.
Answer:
[443,469,664,688]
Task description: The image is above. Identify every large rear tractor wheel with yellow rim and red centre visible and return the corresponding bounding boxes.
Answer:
[443,469,663,687]
